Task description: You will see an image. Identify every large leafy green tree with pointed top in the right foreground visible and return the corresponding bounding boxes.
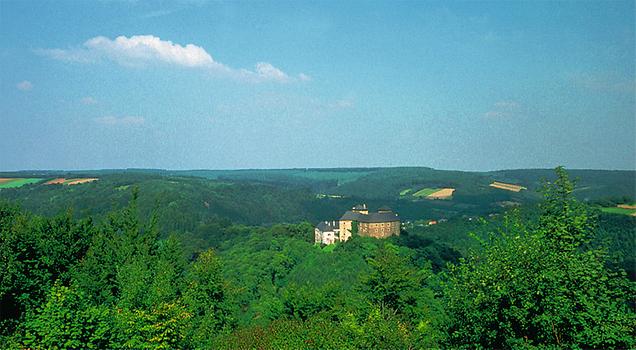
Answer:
[444,168,636,348]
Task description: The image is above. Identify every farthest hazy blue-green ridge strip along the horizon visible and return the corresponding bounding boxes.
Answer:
[22,167,636,199]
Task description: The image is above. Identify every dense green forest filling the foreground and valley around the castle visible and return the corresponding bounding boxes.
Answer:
[0,168,636,349]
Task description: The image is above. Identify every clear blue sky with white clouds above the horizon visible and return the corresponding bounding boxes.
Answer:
[0,0,636,170]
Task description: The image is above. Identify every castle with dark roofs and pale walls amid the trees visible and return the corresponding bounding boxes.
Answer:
[314,204,400,244]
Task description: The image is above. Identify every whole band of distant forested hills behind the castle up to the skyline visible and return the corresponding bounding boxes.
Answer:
[0,168,636,230]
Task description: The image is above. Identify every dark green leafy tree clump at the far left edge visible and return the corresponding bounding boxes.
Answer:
[0,203,93,330]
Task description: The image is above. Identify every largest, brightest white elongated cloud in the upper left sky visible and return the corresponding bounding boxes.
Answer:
[36,35,310,83]
